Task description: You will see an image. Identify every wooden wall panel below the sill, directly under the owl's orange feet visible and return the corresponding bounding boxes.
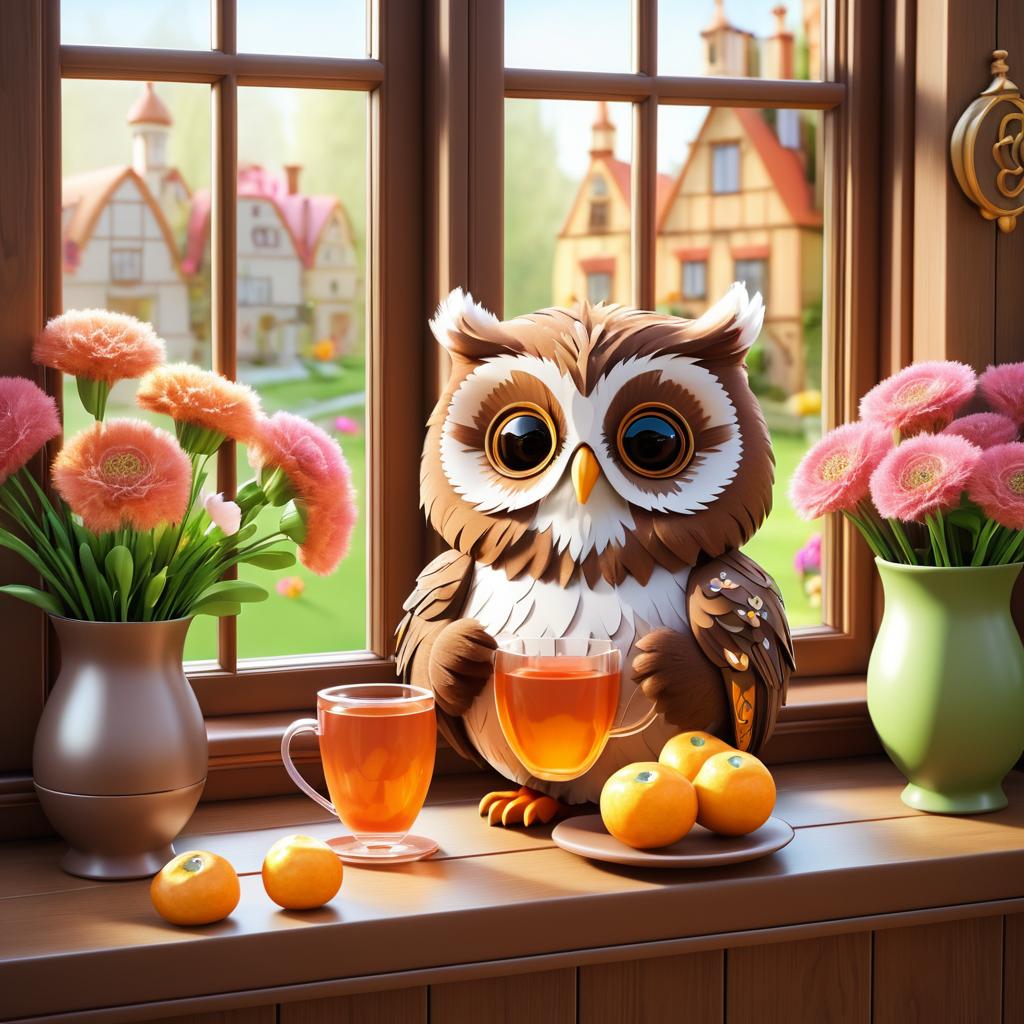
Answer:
[430,968,577,1024]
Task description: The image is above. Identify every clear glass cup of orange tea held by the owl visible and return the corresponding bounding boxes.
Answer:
[495,637,657,782]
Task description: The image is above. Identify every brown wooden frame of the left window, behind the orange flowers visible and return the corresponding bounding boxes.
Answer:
[34,0,427,717]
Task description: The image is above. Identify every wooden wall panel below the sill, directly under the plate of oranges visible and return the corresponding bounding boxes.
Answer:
[579,950,724,1024]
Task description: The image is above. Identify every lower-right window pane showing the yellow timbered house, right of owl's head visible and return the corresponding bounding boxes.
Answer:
[655,106,822,626]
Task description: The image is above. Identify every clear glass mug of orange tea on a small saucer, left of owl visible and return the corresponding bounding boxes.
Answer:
[281,683,437,864]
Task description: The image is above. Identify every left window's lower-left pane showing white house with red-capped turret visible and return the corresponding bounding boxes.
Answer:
[60,79,217,659]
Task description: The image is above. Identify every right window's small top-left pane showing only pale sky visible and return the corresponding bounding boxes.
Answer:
[505,0,633,72]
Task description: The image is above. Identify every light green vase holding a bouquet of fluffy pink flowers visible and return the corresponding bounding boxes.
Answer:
[791,362,1024,813]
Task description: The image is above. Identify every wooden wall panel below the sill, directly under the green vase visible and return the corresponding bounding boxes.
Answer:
[872,918,999,1024]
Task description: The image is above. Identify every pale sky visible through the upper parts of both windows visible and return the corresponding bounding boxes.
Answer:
[60,0,815,177]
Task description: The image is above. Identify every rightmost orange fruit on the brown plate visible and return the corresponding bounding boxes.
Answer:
[693,751,775,836]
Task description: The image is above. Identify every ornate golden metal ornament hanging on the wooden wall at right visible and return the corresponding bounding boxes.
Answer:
[949,50,1024,233]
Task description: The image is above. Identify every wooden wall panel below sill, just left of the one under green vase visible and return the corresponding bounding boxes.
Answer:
[725,932,871,1024]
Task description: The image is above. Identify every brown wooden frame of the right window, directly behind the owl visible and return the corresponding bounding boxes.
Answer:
[427,0,887,696]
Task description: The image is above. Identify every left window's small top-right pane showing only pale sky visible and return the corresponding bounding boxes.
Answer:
[238,0,368,57]
